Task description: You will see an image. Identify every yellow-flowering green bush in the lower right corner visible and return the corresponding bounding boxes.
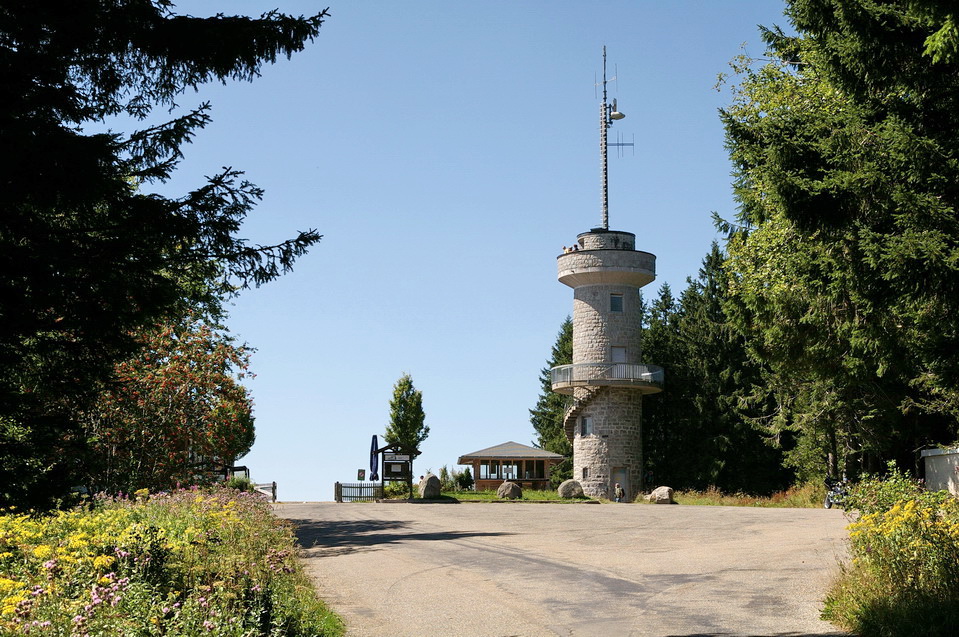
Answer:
[823,466,959,637]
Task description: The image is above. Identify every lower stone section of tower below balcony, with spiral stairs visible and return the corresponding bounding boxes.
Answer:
[573,387,643,502]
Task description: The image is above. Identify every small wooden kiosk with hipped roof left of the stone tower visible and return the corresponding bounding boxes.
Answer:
[456,442,565,491]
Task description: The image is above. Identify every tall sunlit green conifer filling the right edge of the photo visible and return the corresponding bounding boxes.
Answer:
[722,0,959,477]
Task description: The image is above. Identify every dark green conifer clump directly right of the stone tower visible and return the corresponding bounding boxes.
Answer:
[643,252,791,493]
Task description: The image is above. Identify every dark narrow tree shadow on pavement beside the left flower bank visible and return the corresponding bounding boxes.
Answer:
[290,519,513,557]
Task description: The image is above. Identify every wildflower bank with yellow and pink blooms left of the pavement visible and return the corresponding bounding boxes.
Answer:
[0,488,343,637]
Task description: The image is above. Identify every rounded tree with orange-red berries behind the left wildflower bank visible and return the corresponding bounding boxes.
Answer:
[82,317,254,493]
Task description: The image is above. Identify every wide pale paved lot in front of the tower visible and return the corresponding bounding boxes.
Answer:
[276,503,847,637]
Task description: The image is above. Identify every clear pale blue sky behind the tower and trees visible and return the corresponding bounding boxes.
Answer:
[154,0,786,500]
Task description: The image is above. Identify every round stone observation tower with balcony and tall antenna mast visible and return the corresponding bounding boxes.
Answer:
[552,47,663,501]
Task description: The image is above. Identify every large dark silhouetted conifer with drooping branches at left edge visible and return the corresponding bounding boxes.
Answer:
[0,0,326,507]
